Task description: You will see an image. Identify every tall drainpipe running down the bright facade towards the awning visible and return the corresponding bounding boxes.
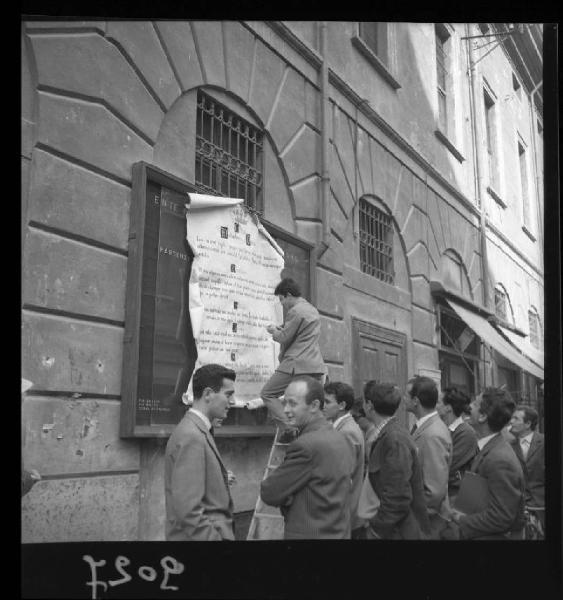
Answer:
[465,23,494,387]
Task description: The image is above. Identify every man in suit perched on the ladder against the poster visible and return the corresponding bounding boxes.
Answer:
[260,278,327,442]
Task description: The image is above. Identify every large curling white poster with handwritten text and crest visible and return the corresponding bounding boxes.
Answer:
[186,194,284,406]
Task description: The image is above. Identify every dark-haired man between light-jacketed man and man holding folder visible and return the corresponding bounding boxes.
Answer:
[438,387,479,503]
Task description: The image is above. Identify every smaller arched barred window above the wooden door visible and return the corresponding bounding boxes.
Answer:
[359,198,395,284]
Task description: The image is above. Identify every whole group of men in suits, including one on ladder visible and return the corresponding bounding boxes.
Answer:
[165,279,544,541]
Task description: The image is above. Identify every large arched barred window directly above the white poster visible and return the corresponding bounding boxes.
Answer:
[195,91,264,213]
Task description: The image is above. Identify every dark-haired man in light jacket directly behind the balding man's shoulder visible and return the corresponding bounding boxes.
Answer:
[324,381,365,537]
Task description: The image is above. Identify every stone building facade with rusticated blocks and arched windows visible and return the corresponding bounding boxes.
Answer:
[21,21,543,542]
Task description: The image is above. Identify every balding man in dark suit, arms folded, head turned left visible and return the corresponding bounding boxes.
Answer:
[260,375,352,539]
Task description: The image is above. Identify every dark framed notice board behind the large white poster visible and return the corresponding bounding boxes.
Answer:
[120,162,314,438]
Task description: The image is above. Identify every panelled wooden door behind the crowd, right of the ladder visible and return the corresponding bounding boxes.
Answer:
[352,318,407,425]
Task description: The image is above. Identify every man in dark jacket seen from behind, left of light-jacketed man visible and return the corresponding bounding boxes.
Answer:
[360,380,430,540]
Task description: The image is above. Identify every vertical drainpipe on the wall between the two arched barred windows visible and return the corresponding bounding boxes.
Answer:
[317,21,330,260]
